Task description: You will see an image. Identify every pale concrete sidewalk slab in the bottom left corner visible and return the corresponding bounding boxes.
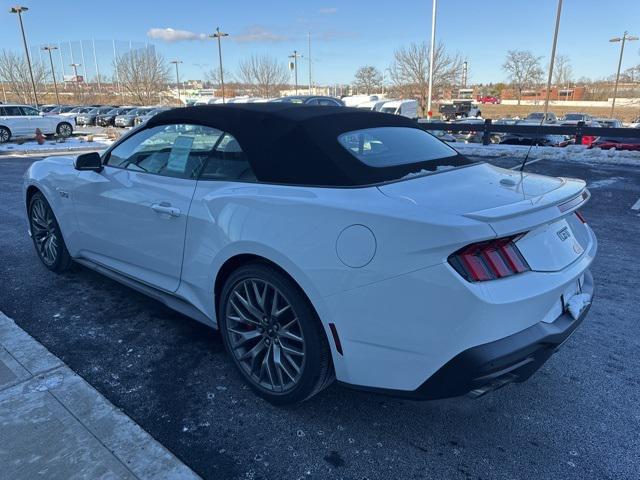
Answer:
[0,312,200,480]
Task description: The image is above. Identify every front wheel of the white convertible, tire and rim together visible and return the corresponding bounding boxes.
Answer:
[28,192,73,273]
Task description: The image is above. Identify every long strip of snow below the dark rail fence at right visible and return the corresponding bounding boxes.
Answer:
[449,143,640,166]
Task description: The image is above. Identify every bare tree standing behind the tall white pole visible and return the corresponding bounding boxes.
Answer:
[390,43,462,115]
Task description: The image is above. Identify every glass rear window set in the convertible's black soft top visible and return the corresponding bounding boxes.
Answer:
[338,127,460,171]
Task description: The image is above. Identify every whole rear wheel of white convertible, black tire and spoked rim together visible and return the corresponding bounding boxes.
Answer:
[218,263,333,403]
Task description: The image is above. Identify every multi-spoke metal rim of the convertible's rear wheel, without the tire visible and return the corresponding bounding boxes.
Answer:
[226,278,305,393]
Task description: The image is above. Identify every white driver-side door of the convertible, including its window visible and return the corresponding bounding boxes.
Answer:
[74,124,221,292]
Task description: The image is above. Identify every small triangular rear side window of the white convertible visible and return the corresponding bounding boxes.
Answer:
[200,133,256,182]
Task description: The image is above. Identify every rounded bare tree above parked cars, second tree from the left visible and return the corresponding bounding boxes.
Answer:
[114,48,170,105]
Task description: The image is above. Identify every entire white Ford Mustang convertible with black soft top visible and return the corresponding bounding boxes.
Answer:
[24,103,597,403]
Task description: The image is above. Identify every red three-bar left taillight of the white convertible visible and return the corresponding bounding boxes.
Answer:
[449,234,530,282]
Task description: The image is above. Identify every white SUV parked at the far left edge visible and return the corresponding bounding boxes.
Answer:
[0,105,73,143]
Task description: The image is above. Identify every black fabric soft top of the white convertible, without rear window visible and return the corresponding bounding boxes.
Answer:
[147,103,468,186]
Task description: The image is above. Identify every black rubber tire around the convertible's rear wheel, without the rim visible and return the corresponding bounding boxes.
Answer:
[218,262,335,405]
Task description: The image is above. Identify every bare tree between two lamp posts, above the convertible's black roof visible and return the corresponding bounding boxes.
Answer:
[238,54,289,98]
